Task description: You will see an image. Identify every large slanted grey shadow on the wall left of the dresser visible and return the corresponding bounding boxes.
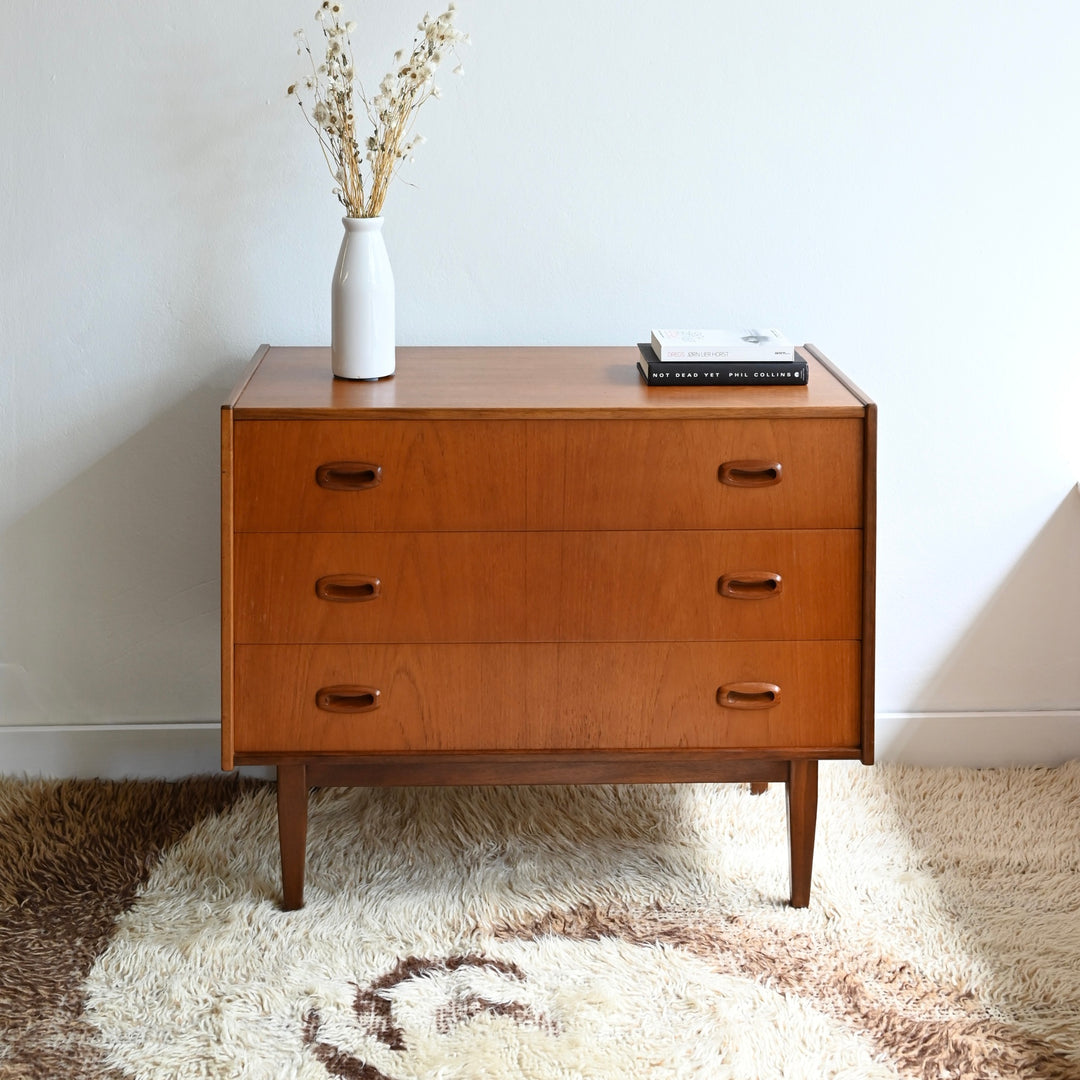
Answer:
[0,373,233,725]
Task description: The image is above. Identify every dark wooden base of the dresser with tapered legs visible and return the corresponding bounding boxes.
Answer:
[259,751,825,912]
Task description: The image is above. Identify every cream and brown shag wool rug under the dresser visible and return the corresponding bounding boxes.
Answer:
[0,762,1080,1080]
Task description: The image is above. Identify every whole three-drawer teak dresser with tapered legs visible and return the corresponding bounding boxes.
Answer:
[221,346,876,909]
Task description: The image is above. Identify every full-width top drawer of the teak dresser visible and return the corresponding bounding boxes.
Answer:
[233,419,863,532]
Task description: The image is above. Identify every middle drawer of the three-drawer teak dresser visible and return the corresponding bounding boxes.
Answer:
[233,529,862,644]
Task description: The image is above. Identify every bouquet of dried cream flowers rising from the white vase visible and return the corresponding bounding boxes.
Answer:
[288,0,469,217]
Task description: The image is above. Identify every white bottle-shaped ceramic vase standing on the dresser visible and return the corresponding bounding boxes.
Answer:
[330,217,394,379]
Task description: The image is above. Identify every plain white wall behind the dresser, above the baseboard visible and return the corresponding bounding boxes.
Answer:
[0,0,1080,770]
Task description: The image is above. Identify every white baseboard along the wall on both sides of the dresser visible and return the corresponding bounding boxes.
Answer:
[0,711,1080,780]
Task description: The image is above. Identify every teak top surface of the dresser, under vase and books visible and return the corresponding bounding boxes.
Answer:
[226,346,868,419]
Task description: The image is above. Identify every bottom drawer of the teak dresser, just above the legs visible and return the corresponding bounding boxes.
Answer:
[233,642,860,754]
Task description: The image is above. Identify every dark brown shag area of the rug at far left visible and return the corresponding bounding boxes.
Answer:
[0,779,252,1080]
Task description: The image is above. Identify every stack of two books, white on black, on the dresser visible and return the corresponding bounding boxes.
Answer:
[637,330,808,387]
